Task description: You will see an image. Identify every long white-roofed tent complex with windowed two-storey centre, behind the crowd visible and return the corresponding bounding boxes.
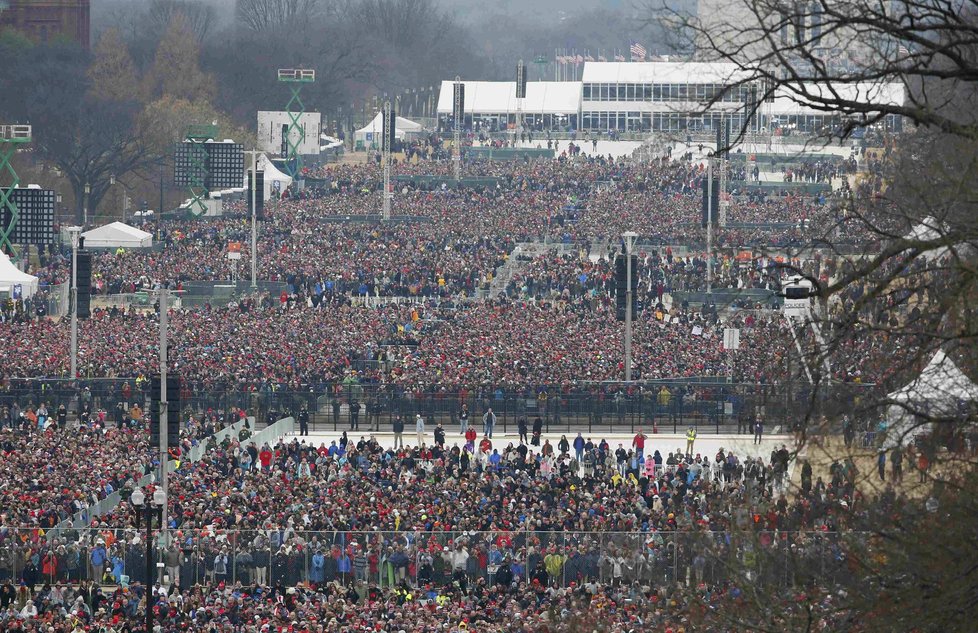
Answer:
[438,62,905,134]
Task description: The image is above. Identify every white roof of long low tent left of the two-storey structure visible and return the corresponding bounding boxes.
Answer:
[438,81,581,114]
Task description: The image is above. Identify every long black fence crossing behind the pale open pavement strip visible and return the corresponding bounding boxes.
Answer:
[0,378,873,433]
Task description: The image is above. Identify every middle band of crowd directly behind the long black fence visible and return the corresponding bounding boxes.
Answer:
[0,286,792,389]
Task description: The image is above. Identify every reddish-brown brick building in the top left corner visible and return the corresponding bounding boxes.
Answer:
[0,0,91,48]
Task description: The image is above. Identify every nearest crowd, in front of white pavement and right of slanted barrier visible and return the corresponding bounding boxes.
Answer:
[0,418,867,633]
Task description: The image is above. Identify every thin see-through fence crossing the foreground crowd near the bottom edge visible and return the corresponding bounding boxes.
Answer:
[0,524,852,587]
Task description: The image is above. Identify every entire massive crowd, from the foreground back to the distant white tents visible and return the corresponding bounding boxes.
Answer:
[0,148,924,633]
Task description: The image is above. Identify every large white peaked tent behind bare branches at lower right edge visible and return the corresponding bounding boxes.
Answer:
[887,350,978,445]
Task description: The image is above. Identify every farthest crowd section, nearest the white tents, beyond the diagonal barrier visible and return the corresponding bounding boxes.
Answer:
[24,158,860,296]
